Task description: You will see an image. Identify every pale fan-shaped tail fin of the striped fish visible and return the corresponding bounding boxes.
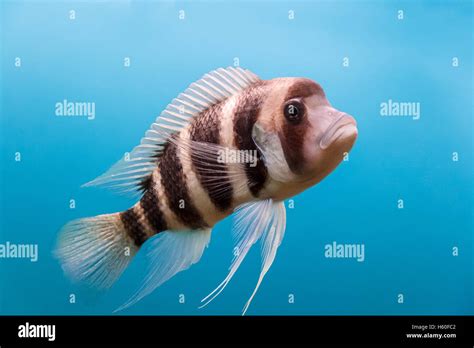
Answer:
[55,213,138,288]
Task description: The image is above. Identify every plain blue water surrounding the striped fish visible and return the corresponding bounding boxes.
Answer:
[0,1,474,315]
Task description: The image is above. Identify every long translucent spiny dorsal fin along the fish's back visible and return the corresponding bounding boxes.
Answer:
[83,67,260,193]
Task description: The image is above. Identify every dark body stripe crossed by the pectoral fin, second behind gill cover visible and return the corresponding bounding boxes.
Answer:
[190,103,233,211]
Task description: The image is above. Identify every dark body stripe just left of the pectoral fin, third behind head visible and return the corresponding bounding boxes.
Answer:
[159,142,208,229]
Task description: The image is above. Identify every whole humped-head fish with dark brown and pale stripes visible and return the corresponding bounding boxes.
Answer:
[55,67,358,315]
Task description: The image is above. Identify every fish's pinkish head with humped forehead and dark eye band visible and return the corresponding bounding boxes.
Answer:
[252,78,357,190]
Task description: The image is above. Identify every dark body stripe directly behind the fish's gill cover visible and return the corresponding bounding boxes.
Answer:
[234,81,268,197]
